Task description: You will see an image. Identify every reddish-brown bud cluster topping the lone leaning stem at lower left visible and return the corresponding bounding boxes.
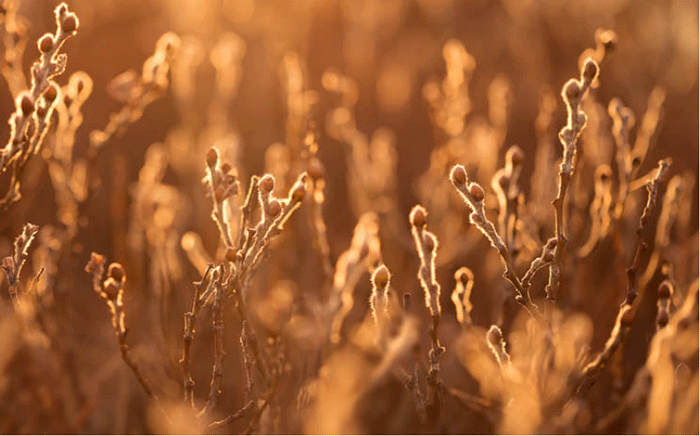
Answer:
[85,253,126,339]
